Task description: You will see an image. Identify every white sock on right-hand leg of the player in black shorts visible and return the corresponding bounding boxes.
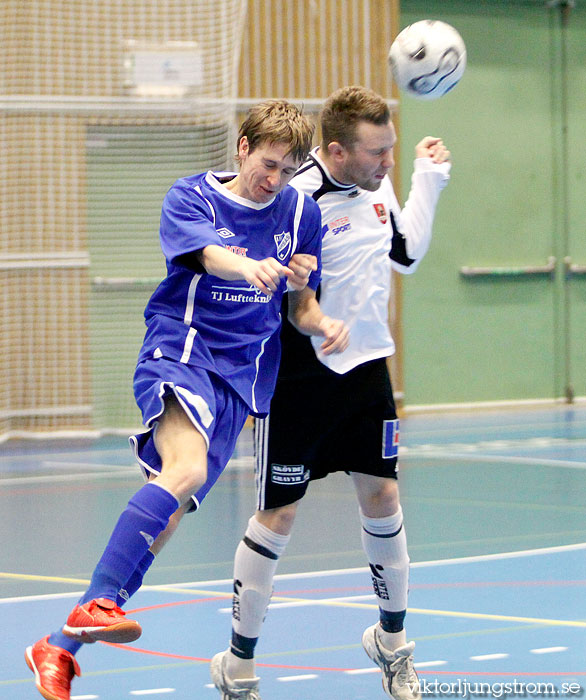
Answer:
[360,506,409,649]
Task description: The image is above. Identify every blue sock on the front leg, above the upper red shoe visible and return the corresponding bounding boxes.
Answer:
[79,482,179,605]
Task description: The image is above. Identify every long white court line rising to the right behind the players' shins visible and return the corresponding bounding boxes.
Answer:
[0,542,586,604]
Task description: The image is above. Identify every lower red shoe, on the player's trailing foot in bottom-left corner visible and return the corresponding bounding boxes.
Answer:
[24,636,81,700]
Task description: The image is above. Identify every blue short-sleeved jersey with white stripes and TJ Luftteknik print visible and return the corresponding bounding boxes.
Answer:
[139,172,321,415]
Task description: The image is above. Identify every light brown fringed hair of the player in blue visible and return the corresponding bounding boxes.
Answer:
[237,100,315,162]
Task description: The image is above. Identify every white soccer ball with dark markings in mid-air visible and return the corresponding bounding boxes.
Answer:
[389,19,466,100]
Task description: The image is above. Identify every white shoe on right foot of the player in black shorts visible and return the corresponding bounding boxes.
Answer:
[362,622,421,700]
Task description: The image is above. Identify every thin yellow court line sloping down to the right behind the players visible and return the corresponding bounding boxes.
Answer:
[0,571,586,628]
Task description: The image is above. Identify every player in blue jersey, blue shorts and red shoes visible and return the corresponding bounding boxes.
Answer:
[25,100,348,700]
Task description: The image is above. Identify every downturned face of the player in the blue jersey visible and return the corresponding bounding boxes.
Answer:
[236,137,301,204]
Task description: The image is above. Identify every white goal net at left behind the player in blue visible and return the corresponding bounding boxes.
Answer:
[0,0,246,439]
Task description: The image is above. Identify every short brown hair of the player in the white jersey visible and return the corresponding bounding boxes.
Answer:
[320,85,391,149]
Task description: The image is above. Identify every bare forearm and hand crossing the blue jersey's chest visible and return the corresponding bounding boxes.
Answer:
[197,245,294,295]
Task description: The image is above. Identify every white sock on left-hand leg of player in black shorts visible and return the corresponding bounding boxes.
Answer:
[226,517,290,679]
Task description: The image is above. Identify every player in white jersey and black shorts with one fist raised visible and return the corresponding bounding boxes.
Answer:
[212,87,450,700]
